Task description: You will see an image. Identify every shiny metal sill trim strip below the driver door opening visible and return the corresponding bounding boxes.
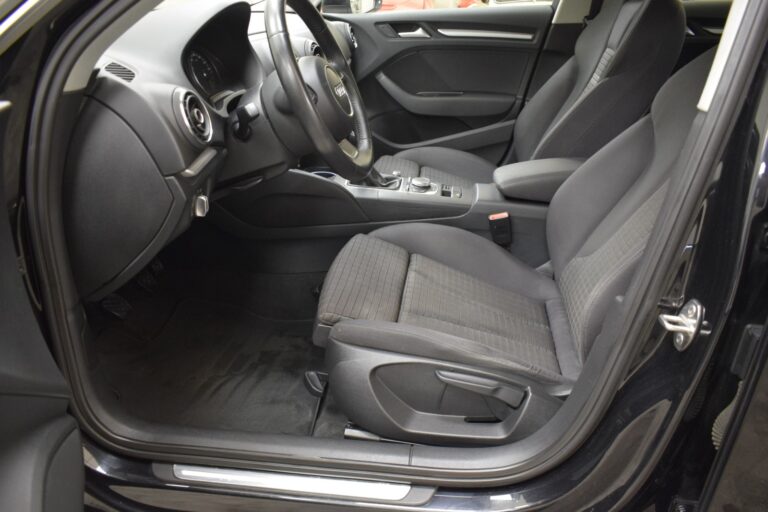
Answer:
[173,464,411,501]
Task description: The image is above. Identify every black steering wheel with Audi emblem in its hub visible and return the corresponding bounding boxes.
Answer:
[265,0,373,182]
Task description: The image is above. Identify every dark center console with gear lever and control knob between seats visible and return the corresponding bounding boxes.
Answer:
[214,169,548,265]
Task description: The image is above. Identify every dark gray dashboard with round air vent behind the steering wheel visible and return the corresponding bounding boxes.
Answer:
[63,0,352,300]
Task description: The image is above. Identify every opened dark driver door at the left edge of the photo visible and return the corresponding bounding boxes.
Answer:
[0,105,84,512]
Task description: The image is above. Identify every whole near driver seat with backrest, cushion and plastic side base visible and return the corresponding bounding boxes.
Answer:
[314,51,714,444]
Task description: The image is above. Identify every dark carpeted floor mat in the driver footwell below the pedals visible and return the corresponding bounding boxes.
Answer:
[95,299,322,435]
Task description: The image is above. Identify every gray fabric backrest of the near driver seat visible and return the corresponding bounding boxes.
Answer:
[547,50,714,362]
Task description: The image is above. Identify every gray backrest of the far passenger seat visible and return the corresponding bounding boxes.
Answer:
[513,0,685,162]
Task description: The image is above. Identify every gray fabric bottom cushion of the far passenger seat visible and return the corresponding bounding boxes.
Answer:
[374,147,496,188]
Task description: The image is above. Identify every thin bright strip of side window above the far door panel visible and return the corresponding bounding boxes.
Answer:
[321,0,551,14]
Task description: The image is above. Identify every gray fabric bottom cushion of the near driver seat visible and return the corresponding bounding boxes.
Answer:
[318,224,580,383]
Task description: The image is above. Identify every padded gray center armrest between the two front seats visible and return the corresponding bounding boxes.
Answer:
[493,158,584,203]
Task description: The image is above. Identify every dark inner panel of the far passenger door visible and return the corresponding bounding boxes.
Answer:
[328,4,552,161]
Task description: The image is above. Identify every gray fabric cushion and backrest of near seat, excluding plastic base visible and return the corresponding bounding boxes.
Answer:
[318,51,714,390]
